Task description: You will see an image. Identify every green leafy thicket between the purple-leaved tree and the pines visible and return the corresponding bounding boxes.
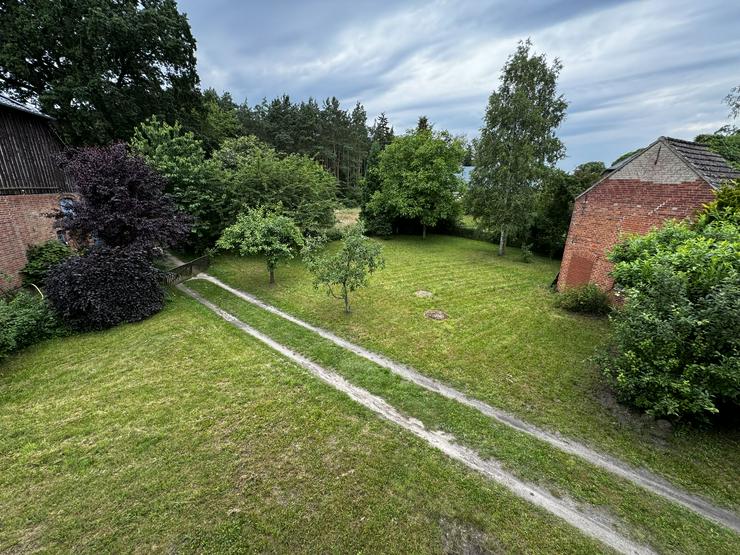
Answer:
[131,119,336,251]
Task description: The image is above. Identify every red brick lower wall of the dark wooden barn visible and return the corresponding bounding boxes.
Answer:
[0,193,68,288]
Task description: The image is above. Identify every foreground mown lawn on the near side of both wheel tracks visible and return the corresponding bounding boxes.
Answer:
[0,295,604,553]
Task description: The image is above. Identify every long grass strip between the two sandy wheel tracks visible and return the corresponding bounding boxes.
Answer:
[187,280,740,554]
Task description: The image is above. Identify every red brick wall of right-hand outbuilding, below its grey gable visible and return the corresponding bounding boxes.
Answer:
[558,178,714,291]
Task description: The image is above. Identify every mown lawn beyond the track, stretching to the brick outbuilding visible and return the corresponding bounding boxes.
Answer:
[209,236,740,510]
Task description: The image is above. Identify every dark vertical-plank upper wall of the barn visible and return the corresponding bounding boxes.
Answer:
[0,107,70,195]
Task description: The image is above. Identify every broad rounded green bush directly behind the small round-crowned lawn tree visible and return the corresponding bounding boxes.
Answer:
[214,137,336,233]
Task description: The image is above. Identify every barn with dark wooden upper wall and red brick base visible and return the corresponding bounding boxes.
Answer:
[0,95,74,289]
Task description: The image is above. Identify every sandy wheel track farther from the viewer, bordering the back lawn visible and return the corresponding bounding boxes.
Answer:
[194,274,740,533]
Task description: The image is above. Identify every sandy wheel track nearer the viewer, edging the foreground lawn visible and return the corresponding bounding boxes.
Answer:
[177,284,653,554]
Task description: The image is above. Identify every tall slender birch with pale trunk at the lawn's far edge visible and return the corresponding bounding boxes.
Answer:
[466,40,567,255]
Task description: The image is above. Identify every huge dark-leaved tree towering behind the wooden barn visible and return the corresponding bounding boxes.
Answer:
[0,0,200,145]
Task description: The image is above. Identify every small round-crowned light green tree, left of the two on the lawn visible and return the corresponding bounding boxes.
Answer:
[216,208,304,283]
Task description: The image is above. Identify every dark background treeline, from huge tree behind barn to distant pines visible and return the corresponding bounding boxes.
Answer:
[0,0,392,204]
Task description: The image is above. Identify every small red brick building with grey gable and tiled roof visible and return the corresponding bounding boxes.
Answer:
[558,137,740,291]
